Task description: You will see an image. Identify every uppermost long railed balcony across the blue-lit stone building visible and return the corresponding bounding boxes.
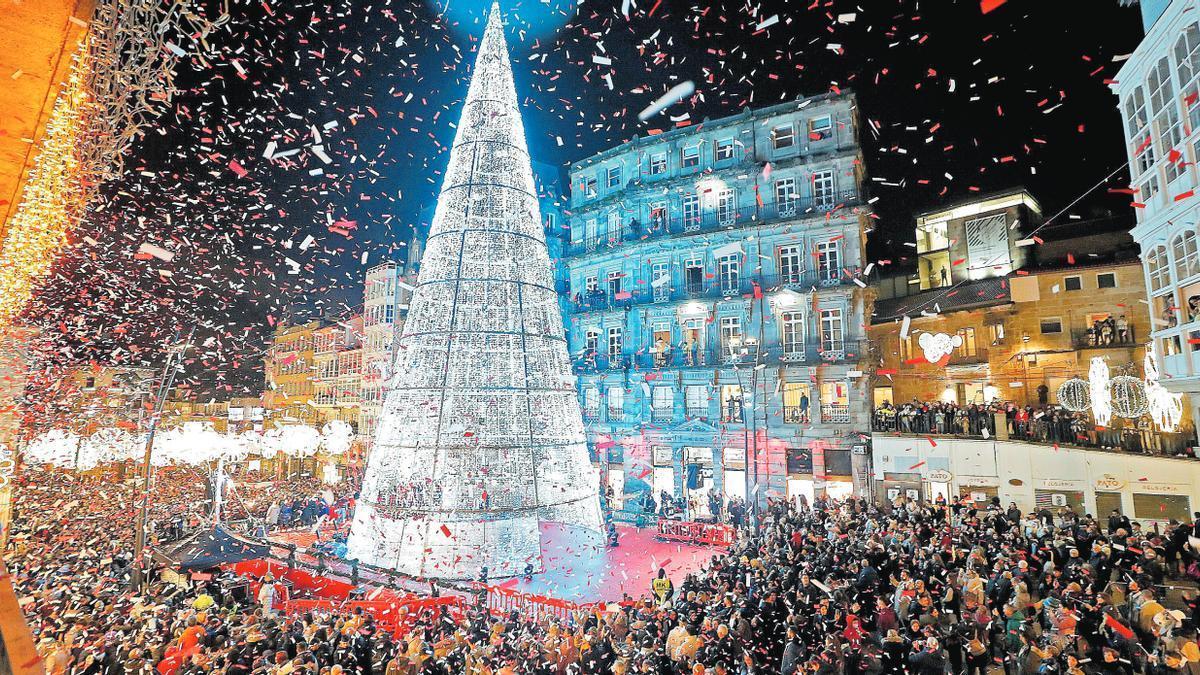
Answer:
[563,190,863,256]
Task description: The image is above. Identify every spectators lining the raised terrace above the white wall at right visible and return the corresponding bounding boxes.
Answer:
[871,400,1195,456]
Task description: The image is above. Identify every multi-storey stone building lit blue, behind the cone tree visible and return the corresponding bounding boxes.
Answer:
[560,92,871,516]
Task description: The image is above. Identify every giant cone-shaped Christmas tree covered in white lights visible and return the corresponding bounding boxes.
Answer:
[349,5,601,579]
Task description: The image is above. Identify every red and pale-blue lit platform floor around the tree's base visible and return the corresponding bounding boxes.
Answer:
[271,524,725,604]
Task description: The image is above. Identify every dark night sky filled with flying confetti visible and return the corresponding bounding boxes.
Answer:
[16,0,1141,399]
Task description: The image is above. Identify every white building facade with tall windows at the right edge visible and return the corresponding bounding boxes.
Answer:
[1111,0,1200,419]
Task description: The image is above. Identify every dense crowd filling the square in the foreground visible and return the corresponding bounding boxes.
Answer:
[6,470,1200,675]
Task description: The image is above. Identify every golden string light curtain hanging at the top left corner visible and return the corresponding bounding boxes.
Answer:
[0,0,228,327]
